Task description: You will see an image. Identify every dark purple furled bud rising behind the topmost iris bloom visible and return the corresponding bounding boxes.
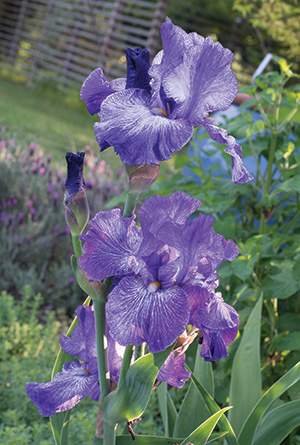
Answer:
[126,48,151,92]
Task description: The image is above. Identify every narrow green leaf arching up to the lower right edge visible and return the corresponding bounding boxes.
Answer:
[238,362,300,445]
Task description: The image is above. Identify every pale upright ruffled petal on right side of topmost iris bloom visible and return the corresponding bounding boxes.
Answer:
[162,33,238,126]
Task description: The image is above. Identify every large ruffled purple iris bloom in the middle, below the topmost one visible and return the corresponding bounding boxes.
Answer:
[79,192,239,360]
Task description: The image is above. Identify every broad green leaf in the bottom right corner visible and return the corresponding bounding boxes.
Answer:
[254,400,300,445]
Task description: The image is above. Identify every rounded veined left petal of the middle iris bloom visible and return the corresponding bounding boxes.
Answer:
[79,209,143,281]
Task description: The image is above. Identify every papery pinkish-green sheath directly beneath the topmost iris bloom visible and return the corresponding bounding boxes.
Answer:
[124,164,159,193]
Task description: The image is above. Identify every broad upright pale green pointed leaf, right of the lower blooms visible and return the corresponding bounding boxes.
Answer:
[228,296,263,434]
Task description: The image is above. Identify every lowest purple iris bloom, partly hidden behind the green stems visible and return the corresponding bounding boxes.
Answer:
[26,306,189,417]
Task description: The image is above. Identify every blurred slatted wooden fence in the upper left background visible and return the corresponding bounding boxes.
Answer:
[0,0,166,85]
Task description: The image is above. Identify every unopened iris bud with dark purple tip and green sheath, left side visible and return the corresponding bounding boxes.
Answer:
[64,152,89,236]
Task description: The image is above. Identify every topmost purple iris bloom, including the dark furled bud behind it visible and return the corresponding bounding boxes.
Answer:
[81,18,252,184]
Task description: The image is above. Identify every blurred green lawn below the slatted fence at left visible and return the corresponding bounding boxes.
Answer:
[0,75,121,170]
